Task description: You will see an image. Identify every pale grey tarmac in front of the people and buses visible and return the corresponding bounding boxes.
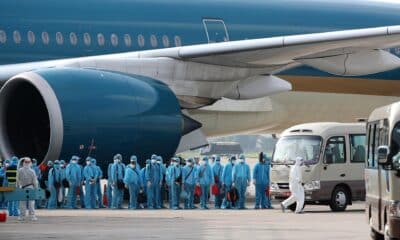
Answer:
[0,202,370,240]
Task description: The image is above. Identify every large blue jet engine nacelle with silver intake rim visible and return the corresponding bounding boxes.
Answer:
[0,68,184,169]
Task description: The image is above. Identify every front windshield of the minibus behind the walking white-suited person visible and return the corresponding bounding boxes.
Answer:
[272,136,322,165]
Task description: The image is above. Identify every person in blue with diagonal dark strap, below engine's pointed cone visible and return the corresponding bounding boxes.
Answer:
[182,158,198,209]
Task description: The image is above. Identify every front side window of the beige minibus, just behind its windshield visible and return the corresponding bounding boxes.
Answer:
[325,137,346,164]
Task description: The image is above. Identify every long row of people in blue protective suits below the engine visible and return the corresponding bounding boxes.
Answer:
[0,154,272,218]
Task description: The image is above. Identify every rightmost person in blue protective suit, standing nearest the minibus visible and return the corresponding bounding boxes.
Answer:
[253,153,271,209]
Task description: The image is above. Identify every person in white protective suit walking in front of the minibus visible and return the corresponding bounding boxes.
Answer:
[282,157,304,213]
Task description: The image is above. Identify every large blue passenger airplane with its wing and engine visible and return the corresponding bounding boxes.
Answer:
[0,0,400,169]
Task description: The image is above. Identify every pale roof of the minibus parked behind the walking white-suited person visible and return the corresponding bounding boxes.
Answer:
[282,122,366,136]
